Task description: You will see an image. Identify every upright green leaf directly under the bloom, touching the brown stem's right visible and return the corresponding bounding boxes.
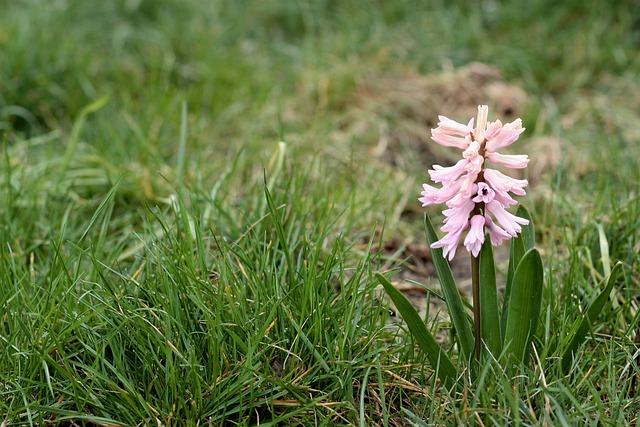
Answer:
[480,237,502,358]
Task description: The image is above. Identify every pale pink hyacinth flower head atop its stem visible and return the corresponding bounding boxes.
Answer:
[418,105,529,260]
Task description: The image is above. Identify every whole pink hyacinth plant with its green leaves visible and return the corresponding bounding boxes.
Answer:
[377,105,618,386]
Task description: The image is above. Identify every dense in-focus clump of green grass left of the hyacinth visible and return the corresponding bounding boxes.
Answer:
[2,148,424,425]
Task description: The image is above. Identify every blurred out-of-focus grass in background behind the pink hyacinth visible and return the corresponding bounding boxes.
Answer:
[0,0,640,264]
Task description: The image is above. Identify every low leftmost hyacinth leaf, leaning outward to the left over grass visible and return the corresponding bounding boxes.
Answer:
[376,273,457,387]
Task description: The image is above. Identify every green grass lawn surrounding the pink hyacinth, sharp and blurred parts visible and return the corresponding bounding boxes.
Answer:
[0,0,640,426]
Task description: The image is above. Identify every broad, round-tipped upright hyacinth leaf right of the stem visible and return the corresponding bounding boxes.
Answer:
[504,249,544,365]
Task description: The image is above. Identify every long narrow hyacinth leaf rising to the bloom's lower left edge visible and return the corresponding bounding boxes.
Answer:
[424,214,475,360]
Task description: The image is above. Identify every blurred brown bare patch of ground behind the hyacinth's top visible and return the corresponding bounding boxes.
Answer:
[342,63,528,171]
